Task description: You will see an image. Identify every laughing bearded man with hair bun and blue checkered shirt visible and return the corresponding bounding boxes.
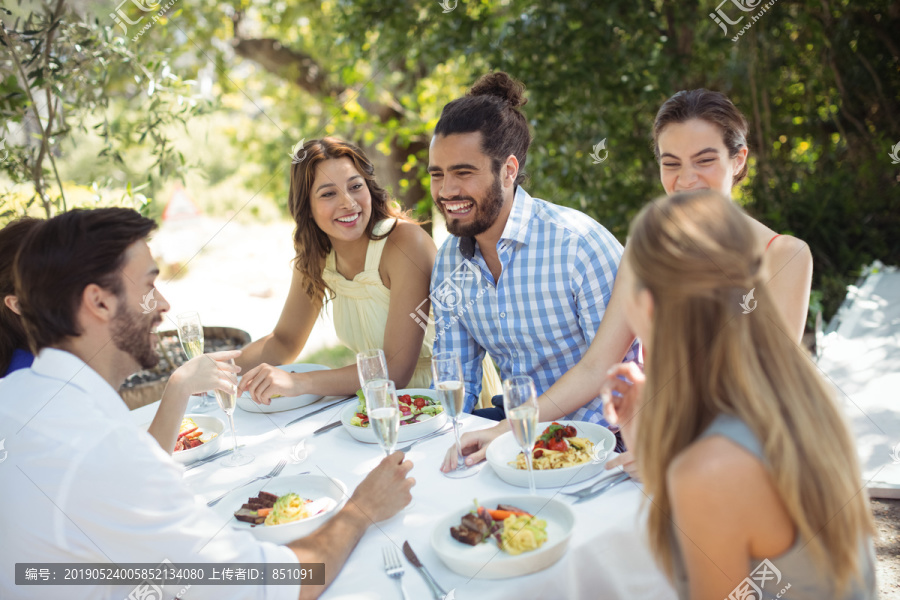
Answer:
[428,72,638,471]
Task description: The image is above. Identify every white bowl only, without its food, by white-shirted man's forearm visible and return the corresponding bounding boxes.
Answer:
[213,475,349,544]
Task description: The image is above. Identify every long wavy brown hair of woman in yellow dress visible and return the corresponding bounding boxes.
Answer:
[288,137,411,302]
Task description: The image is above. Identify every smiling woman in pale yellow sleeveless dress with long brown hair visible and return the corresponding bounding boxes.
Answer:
[237,138,436,404]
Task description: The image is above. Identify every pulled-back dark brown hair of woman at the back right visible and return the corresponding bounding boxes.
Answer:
[653,88,750,186]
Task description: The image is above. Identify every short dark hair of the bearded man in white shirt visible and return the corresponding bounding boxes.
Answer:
[15,208,156,354]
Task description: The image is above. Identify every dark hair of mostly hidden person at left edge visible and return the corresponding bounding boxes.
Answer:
[0,217,41,376]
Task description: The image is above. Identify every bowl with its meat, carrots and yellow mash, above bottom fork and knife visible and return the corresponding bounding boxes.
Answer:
[431,496,575,579]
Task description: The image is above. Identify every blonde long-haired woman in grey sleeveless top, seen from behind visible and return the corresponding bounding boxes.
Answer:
[604,190,875,600]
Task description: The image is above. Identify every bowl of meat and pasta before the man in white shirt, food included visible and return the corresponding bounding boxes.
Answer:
[213,475,350,544]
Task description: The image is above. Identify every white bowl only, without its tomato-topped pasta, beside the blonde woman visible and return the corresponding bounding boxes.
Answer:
[485,421,616,488]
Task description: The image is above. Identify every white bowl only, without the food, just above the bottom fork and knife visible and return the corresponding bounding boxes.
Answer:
[431,496,575,579]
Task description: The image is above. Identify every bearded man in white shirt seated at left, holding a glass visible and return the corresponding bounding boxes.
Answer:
[0,209,415,600]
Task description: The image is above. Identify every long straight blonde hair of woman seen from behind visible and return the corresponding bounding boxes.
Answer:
[627,190,874,591]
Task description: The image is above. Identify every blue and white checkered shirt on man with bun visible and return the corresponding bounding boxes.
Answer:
[431,187,639,424]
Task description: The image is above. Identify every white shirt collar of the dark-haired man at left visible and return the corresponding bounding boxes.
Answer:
[31,348,129,421]
